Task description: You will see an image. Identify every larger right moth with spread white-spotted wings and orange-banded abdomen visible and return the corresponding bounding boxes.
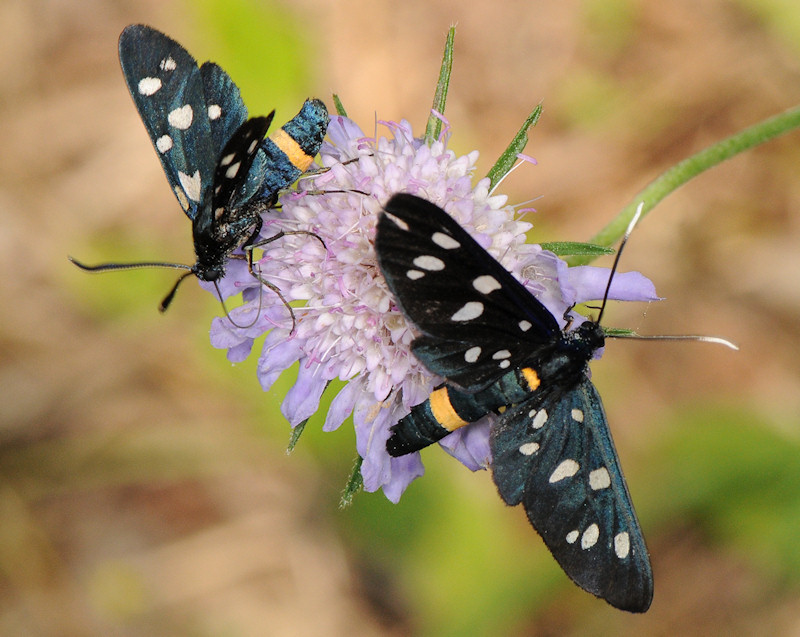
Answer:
[375,194,653,612]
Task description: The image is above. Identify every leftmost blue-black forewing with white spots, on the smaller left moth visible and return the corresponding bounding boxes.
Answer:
[119,24,219,219]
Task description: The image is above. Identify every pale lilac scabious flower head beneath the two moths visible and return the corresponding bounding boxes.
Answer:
[205,116,655,502]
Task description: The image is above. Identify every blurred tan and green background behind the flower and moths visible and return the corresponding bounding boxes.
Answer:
[0,0,800,637]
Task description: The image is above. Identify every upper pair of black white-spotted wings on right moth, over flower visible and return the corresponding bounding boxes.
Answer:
[375,194,561,392]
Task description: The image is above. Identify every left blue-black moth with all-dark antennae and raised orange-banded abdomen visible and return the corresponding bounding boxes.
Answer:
[72,24,329,311]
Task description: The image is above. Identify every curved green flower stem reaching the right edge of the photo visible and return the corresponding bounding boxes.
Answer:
[567,106,800,265]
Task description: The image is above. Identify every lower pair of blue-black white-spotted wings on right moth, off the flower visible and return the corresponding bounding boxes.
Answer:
[490,379,653,612]
